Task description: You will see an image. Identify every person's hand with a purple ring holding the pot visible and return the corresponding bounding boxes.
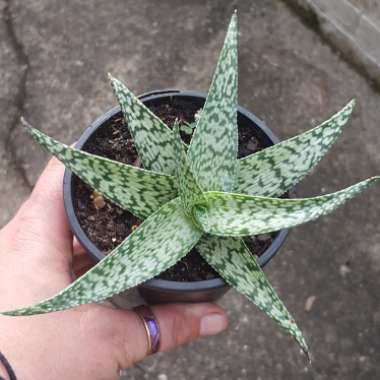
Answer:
[0,159,227,380]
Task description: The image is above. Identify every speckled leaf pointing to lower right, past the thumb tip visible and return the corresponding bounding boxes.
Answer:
[197,235,308,354]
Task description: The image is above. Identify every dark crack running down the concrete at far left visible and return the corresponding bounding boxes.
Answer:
[3,0,33,189]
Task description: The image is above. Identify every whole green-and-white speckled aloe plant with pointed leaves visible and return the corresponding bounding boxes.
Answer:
[4,15,380,360]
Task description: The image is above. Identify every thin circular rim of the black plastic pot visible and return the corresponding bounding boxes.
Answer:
[63,89,294,292]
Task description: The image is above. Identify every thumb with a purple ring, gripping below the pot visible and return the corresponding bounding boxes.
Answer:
[108,303,228,368]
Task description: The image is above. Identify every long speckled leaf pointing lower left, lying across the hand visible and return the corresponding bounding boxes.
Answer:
[2,198,202,316]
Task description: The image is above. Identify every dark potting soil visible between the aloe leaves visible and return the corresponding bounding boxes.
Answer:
[73,100,275,281]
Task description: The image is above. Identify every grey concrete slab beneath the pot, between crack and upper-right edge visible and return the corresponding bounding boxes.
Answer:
[0,0,380,380]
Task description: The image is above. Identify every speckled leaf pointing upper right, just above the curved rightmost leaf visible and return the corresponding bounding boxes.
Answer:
[235,100,355,197]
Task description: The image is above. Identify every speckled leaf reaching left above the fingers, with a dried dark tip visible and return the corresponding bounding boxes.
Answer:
[24,121,178,219]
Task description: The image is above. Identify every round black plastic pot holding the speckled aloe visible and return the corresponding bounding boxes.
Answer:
[63,89,288,304]
